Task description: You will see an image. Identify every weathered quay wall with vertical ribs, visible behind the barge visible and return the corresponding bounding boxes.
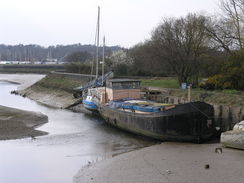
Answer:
[145,95,244,131]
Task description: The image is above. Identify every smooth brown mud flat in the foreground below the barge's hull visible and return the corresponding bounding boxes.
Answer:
[74,143,244,183]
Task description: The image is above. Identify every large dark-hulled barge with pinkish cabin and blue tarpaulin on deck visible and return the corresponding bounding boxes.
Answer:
[92,79,214,143]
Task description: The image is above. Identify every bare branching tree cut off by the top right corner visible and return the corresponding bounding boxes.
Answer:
[206,0,244,53]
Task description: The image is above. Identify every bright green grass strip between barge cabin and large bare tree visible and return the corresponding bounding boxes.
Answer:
[141,77,179,88]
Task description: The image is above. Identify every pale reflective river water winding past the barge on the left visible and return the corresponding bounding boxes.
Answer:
[0,81,155,183]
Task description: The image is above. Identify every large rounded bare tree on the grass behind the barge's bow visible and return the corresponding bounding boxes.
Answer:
[152,14,208,84]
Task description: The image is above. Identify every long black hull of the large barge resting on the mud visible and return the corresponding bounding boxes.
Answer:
[99,102,214,143]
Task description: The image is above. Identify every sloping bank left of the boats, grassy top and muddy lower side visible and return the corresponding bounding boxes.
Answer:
[20,74,87,108]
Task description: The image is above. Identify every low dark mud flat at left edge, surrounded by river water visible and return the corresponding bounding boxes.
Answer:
[0,105,48,140]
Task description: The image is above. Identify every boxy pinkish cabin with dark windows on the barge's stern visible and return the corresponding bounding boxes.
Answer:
[106,79,141,101]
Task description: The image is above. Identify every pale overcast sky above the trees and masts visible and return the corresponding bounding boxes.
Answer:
[0,0,219,47]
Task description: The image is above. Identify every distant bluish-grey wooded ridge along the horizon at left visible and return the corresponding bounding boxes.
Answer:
[0,44,121,62]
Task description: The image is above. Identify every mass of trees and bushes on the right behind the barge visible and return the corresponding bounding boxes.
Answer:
[109,0,244,89]
